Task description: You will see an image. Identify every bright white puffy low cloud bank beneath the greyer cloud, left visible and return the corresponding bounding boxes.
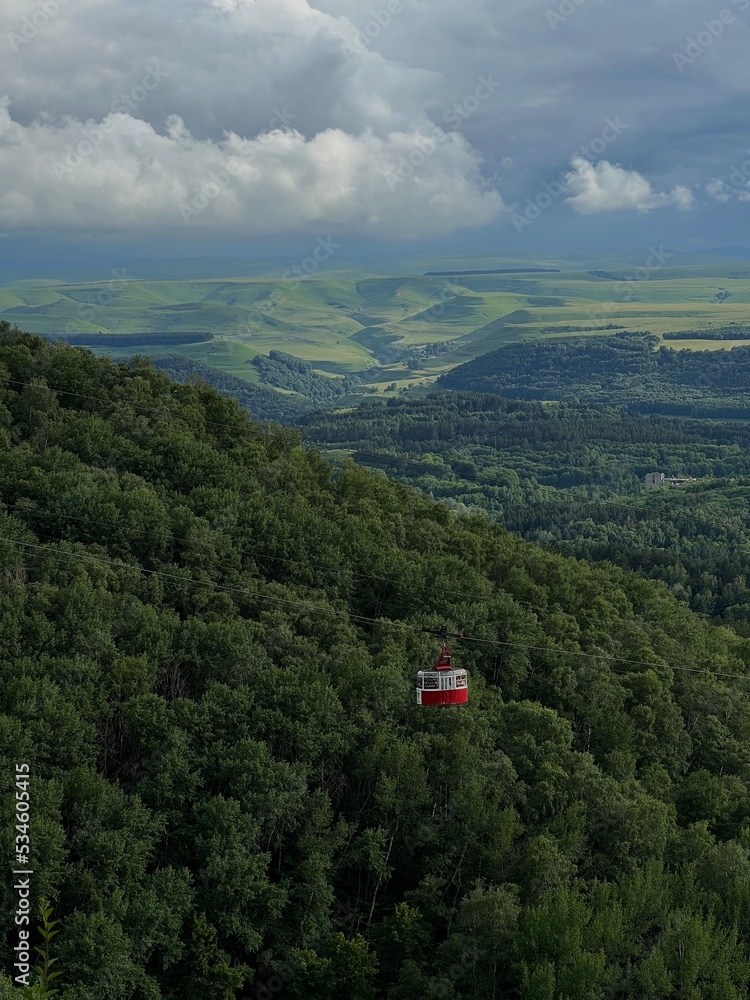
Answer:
[0,99,504,238]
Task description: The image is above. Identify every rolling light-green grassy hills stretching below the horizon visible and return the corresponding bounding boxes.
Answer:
[0,255,750,392]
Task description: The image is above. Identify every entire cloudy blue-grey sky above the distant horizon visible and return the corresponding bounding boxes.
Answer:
[0,0,750,255]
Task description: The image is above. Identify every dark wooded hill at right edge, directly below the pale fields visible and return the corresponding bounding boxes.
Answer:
[438,332,750,419]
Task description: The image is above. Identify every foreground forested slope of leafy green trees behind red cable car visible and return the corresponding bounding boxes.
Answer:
[5,324,750,1000]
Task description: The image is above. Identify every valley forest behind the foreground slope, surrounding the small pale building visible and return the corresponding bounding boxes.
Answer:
[301,392,750,634]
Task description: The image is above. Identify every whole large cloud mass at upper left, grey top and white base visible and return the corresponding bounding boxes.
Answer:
[0,0,505,240]
